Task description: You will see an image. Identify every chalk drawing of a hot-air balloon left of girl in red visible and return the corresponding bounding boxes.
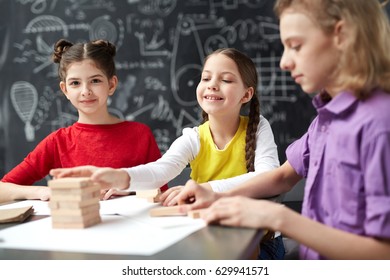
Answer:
[10,81,38,142]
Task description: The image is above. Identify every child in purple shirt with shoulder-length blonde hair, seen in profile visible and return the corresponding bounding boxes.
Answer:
[173,0,390,259]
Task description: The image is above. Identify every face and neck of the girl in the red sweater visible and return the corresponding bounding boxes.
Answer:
[60,59,117,123]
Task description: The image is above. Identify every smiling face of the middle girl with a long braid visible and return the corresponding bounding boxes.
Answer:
[196,53,254,117]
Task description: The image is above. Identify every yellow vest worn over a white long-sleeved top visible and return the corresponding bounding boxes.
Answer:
[190,116,249,184]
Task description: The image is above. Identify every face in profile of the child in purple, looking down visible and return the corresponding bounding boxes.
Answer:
[280,8,340,96]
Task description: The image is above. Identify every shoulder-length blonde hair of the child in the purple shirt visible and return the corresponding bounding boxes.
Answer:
[274,0,390,99]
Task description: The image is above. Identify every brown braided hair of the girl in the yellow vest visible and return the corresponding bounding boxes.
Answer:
[202,48,260,172]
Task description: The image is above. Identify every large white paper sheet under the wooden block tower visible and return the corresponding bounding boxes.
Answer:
[0,196,206,256]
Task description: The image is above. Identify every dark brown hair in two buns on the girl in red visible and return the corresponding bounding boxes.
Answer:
[52,39,116,81]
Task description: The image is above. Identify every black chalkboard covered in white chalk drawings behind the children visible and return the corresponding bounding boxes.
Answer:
[0,0,315,183]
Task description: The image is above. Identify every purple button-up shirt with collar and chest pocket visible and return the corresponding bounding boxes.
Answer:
[286,91,390,259]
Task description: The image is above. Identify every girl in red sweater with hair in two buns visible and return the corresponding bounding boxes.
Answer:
[0,39,161,202]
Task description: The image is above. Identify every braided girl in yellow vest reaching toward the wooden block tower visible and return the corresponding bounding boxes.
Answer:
[51,48,284,254]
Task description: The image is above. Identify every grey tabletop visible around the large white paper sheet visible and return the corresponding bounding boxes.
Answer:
[0,215,263,260]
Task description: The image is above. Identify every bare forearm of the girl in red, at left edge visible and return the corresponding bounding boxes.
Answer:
[0,182,50,203]
